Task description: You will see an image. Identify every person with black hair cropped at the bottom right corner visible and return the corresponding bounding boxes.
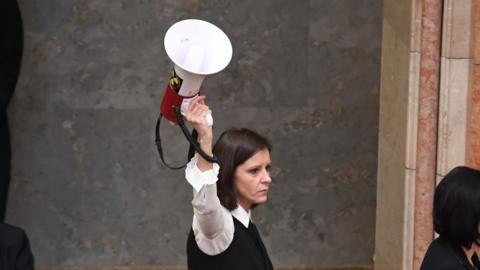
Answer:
[420,167,480,270]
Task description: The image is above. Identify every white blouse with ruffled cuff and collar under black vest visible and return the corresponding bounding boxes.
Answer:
[185,155,250,255]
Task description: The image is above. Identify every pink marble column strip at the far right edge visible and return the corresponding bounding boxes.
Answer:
[467,0,480,168]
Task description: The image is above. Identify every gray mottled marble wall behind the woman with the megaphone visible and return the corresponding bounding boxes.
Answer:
[7,0,382,266]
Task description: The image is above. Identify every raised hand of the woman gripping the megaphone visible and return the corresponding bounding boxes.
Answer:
[182,96,213,139]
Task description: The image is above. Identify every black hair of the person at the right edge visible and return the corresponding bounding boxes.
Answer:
[433,167,480,248]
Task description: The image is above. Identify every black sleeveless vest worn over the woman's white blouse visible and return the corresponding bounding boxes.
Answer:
[187,217,273,270]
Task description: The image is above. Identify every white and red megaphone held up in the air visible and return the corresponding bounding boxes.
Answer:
[160,19,232,125]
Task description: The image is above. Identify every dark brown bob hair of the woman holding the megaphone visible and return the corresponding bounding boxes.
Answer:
[213,128,272,210]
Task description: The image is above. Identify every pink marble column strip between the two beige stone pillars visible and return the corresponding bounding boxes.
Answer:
[413,0,442,270]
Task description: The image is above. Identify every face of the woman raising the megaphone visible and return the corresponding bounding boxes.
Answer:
[233,149,272,211]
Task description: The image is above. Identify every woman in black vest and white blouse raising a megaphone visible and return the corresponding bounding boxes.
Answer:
[185,96,273,270]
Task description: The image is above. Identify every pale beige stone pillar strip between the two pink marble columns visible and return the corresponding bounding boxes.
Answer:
[437,0,472,177]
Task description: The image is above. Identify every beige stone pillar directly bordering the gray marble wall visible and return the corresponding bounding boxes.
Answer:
[375,0,421,270]
